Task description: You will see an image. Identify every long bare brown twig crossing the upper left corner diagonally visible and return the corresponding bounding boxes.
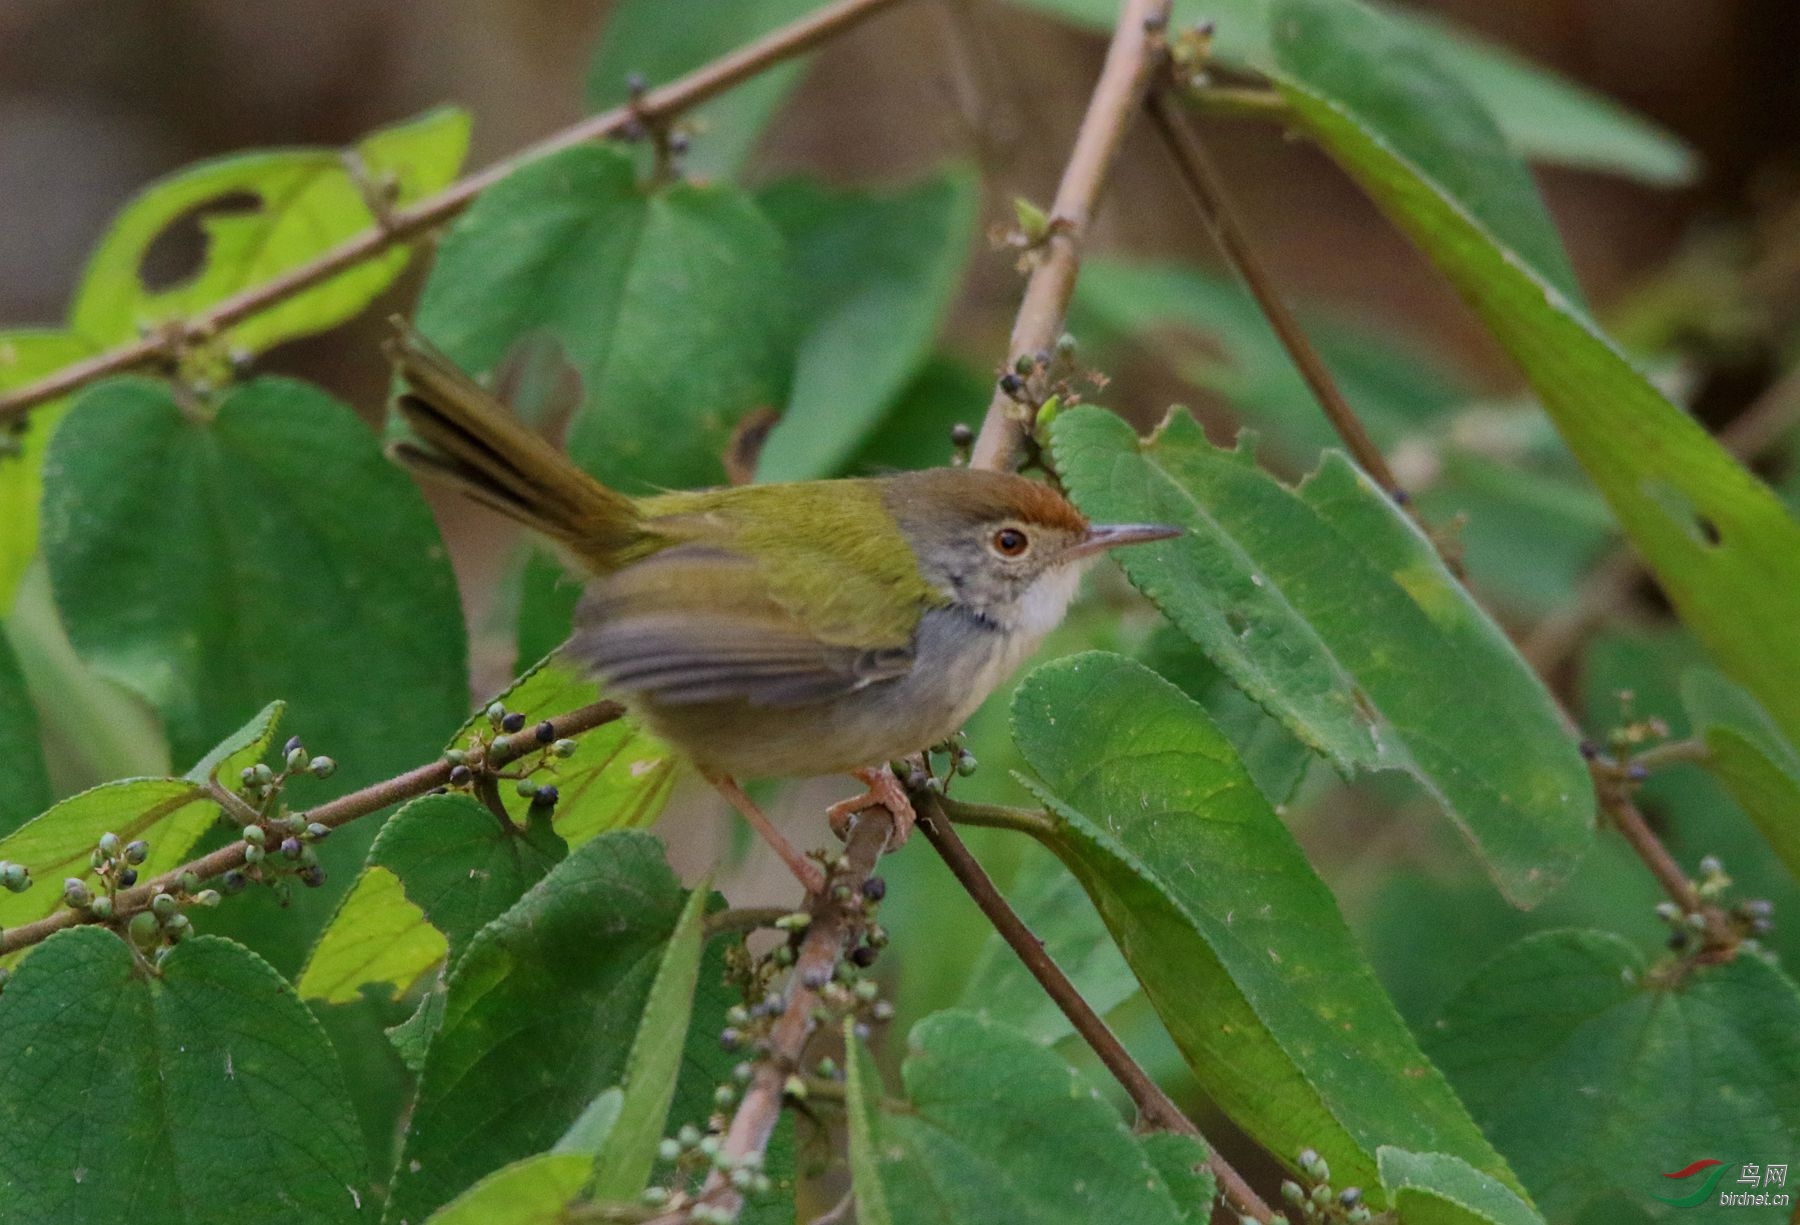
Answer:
[0,0,898,425]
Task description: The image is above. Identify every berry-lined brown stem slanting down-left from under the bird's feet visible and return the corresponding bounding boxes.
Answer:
[655,808,895,1225]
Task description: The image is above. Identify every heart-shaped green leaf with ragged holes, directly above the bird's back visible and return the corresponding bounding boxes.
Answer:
[418,146,794,493]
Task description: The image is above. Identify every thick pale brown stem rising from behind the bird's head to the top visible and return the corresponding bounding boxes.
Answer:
[968,0,1170,469]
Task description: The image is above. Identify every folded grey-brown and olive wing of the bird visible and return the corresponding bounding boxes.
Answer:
[569,543,913,707]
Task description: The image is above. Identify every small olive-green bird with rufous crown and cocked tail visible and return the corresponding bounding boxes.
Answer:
[385,320,1181,892]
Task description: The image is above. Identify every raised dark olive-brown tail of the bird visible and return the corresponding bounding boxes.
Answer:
[385,320,639,570]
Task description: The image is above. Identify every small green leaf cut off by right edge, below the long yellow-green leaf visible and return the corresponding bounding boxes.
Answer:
[1681,669,1800,880]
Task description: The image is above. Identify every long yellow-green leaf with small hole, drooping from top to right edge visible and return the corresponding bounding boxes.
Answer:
[1276,0,1800,755]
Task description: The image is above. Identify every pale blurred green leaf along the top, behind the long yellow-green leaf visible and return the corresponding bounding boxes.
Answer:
[1015,0,1697,187]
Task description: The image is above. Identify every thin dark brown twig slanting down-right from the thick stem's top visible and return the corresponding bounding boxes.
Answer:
[1148,83,1406,504]
